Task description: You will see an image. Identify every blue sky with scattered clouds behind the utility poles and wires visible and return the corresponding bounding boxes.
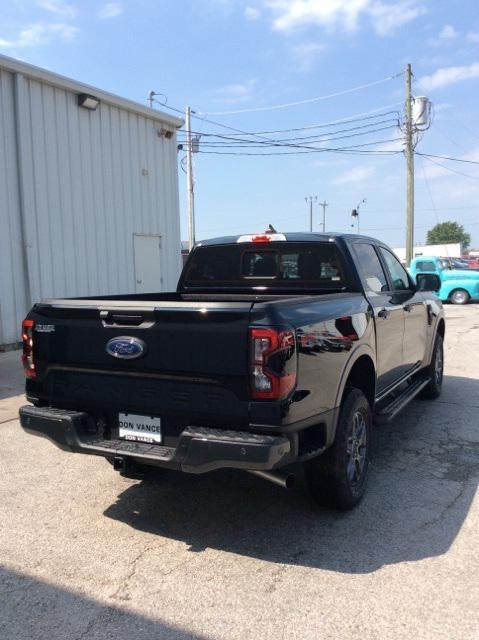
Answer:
[0,0,479,247]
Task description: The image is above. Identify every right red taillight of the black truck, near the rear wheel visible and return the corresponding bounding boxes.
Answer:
[250,328,297,400]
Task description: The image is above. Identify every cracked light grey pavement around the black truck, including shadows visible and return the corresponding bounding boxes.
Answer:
[0,305,479,640]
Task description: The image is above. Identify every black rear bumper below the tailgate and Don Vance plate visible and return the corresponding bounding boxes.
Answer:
[20,405,292,473]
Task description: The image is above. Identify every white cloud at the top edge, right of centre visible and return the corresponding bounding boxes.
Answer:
[267,0,426,35]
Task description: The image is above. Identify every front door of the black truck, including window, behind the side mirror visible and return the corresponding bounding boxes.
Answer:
[378,247,428,373]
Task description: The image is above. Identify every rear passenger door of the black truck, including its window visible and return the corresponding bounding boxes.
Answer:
[353,241,404,393]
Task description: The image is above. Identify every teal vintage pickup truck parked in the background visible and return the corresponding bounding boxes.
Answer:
[409,256,479,304]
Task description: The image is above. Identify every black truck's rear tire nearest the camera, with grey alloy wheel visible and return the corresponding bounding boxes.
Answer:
[304,388,372,510]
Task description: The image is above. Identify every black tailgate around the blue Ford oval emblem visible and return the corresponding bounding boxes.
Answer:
[27,300,252,428]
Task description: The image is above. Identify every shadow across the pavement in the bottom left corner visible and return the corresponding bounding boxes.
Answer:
[0,566,208,640]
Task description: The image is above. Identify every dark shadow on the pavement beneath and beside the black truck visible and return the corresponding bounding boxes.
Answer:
[105,376,479,573]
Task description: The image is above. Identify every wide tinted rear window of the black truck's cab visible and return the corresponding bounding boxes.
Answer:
[183,242,346,289]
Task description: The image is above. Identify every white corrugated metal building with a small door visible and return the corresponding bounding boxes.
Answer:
[0,56,182,345]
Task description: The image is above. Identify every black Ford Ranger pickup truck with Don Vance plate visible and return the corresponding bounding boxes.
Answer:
[20,233,445,509]
